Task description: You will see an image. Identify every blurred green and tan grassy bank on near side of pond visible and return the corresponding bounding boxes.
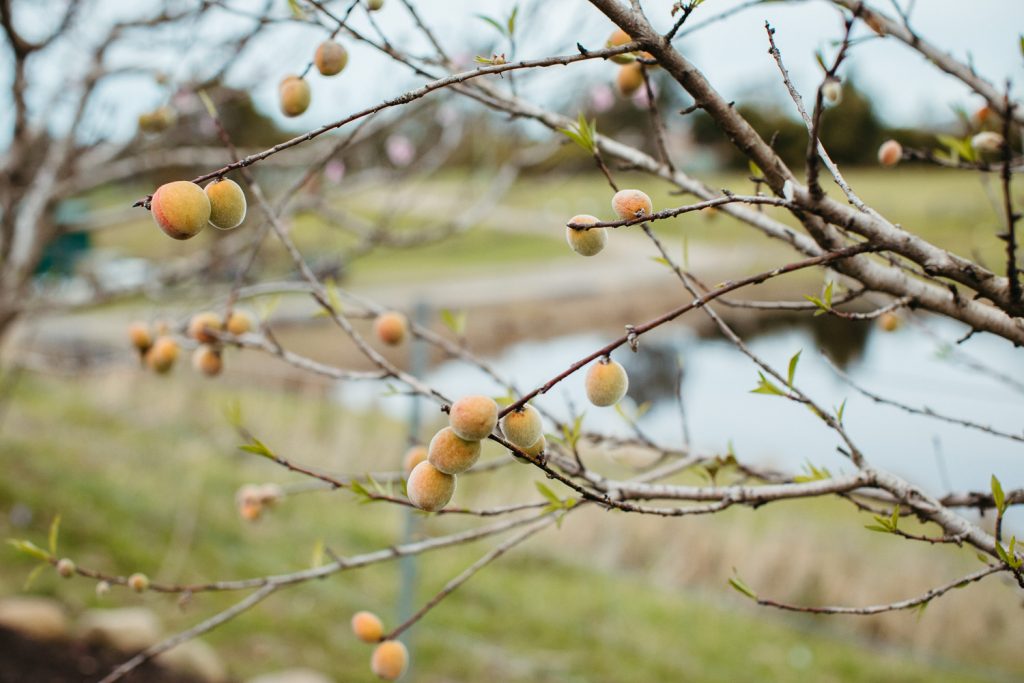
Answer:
[0,371,1024,683]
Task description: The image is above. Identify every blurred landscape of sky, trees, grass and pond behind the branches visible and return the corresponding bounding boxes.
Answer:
[0,0,1024,683]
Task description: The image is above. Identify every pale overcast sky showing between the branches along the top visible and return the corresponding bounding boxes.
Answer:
[0,0,1024,144]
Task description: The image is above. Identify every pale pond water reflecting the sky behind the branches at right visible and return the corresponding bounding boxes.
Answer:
[331,315,1024,526]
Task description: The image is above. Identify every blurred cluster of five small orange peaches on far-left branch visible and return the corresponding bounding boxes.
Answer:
[128,310,252,377]
